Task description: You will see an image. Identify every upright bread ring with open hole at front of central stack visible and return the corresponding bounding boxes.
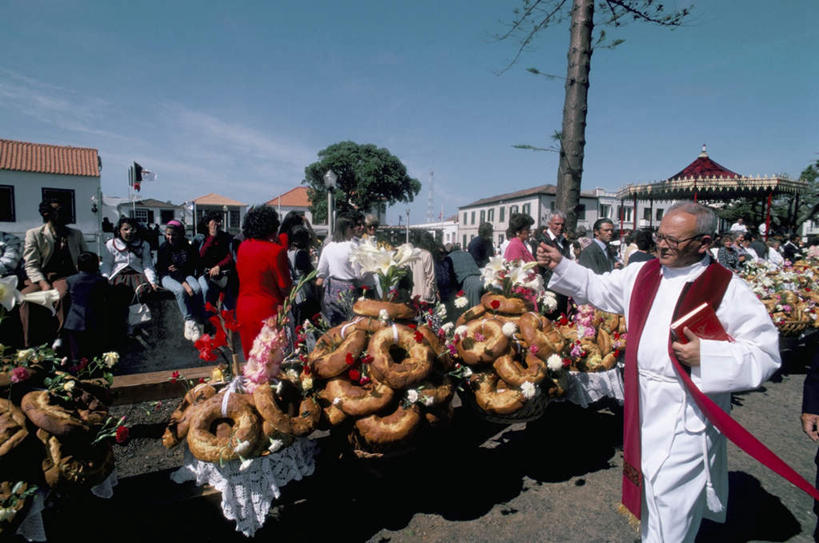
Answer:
[367,324,435,389]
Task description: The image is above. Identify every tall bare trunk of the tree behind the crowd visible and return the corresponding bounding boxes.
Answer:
[555,0,594,232]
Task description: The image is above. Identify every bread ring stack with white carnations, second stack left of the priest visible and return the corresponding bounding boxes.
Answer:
[455,293,565,421]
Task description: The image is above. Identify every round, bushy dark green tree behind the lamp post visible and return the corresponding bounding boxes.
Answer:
[302,141,421,222]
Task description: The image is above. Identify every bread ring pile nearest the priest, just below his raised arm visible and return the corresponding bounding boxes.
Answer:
[556,306,626,372]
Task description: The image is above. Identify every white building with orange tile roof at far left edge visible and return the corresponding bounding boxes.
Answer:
[0,139,102,243]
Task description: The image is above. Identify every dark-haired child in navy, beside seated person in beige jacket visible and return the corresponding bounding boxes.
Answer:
[63,252,109,361]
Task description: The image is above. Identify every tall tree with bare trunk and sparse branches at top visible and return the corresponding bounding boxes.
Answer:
[498,0,689,230]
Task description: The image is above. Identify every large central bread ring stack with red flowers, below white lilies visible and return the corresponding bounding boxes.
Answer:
[306,299,454,458]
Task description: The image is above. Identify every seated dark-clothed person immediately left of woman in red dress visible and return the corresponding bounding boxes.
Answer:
[196,211,235,314]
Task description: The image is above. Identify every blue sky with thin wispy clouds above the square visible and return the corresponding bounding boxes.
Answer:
[0,0,819,223]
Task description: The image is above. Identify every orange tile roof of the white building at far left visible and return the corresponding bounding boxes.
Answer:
[0,139,100,177]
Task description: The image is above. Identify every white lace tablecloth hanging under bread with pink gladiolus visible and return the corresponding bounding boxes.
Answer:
[171,438,317,537]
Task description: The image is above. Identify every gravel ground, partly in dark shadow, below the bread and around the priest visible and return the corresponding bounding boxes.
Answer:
[24,344,816,542]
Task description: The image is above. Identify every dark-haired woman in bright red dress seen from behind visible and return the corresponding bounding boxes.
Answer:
[236,206,291,360]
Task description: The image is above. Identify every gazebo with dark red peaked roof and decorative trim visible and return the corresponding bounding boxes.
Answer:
[617,145,808,237]
